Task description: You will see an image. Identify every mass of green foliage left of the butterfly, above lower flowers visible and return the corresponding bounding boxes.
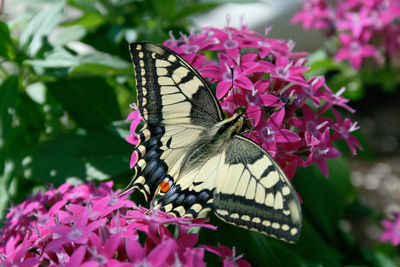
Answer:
[0,0,218,220]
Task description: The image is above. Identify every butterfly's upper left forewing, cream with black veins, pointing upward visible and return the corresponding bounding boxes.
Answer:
[130,42,223,126]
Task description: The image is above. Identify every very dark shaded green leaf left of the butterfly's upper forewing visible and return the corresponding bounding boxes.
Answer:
[47,77,121,129]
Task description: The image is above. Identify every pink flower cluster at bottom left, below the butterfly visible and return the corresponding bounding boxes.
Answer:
[0,182,250,267]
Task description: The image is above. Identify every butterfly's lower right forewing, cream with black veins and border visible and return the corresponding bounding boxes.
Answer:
[213,135,301,242]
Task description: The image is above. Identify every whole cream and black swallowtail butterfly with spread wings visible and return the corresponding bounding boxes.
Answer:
[129,42,301,243]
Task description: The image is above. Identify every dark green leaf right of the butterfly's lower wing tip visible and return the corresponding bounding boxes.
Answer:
[293,156,355,240]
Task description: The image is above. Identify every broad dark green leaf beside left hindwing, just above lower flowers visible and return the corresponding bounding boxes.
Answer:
[28,126,132,185]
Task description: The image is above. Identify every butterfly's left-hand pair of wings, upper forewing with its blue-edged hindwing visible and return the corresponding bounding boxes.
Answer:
[129,42,223,199]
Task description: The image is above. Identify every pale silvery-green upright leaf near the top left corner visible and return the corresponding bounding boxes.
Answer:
[20,0,65,56]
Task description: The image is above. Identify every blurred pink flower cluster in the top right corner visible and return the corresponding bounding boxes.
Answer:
[292,0,400,69]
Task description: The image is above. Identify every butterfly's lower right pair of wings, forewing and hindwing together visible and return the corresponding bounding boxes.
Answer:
[160,135,301,242]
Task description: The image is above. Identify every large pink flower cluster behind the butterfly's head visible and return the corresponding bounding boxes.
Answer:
[127,22,361,177]
